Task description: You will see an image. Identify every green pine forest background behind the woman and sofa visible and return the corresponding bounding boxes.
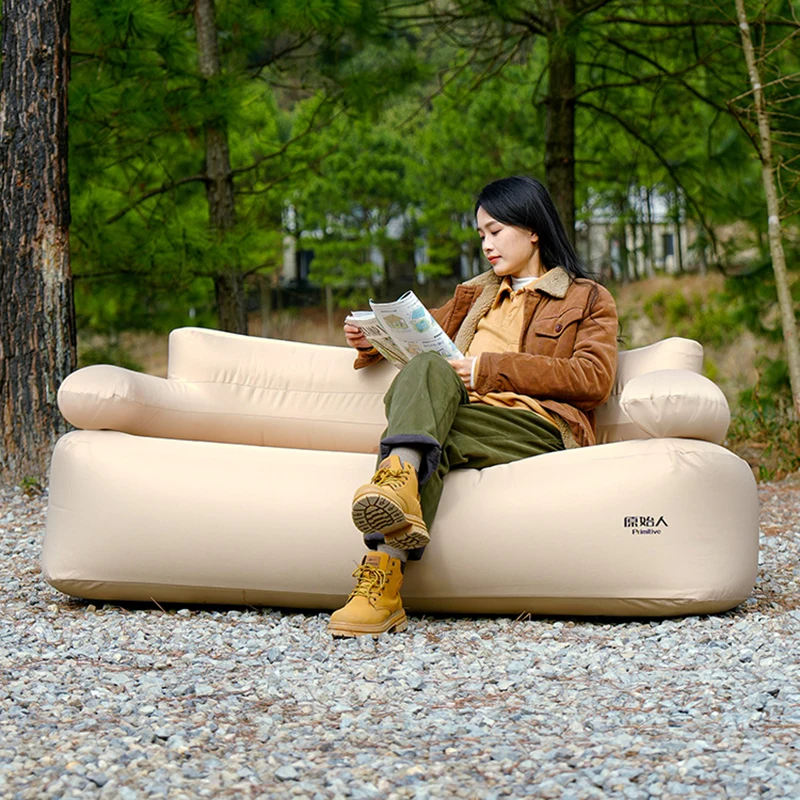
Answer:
[0,0,800,478]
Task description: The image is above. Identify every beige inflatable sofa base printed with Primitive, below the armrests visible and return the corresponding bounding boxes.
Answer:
[43,431,758,617]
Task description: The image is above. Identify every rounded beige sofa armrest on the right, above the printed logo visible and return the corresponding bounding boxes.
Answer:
[620,369,731,444]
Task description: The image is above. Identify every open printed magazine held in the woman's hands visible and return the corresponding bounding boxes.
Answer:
[345,292,464,368]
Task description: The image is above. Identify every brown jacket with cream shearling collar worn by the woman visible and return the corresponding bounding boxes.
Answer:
[354,267,618,446]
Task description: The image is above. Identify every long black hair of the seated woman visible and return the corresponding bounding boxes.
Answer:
[475,175,594,280]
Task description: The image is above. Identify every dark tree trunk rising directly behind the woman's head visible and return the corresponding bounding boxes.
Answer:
[544,0,575,244]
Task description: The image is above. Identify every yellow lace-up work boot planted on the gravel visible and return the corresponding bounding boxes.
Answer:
[328,553,408,636]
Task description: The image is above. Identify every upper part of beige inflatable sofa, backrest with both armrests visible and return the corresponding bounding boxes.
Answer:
[58,328,712,453]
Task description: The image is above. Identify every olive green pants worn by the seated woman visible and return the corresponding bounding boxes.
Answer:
[365,353,564,558]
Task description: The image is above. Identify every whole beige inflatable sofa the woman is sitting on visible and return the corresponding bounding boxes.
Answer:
[43,328,758,617]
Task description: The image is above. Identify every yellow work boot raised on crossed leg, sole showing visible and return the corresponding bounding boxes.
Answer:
[353,456,431,550]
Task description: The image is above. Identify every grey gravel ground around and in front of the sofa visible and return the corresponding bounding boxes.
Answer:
[0,476,800,800]
